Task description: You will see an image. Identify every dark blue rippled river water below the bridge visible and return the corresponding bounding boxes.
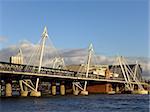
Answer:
[0,94,150,112]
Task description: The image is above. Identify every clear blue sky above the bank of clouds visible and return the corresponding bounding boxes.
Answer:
[0,0,149,57]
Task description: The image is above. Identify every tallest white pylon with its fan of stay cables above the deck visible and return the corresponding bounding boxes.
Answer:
[23,27,65,69]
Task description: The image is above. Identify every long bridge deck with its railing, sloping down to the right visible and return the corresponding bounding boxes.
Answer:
[0,62,147,85]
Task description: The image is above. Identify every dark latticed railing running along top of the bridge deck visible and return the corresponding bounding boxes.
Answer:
[0,62,122,80]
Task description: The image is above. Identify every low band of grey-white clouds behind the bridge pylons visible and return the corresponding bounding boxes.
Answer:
[0,40,150,79]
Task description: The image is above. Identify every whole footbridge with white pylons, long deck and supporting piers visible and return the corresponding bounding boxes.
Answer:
[0,27,149,96]
